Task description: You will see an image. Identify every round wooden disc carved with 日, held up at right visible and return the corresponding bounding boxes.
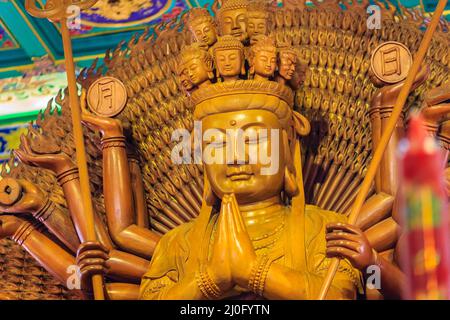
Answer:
[371,41,412,84]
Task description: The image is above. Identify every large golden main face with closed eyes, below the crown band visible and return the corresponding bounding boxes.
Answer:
[202,110,285,204]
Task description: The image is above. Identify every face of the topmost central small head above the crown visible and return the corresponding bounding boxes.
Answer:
[220,8,247,41]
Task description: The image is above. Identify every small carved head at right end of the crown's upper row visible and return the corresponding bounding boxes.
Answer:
[247,0,269,44]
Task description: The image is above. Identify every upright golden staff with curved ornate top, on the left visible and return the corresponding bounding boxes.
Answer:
[25,0,105,300]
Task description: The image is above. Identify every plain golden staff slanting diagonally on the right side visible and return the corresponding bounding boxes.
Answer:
[318,0,447,300]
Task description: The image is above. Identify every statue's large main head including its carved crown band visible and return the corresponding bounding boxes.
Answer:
[193,80,306,204]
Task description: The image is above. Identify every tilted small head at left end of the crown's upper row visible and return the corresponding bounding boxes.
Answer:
[187,8,217,47]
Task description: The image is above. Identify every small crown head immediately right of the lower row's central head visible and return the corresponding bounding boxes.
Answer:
[249,36,277,80]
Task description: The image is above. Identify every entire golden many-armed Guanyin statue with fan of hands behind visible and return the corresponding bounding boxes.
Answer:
[0,0,450,299]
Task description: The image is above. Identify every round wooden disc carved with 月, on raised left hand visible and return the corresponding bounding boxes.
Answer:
[87,77,127,118]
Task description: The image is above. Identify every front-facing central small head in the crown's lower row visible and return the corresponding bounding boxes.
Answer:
[213,36,245,81]
